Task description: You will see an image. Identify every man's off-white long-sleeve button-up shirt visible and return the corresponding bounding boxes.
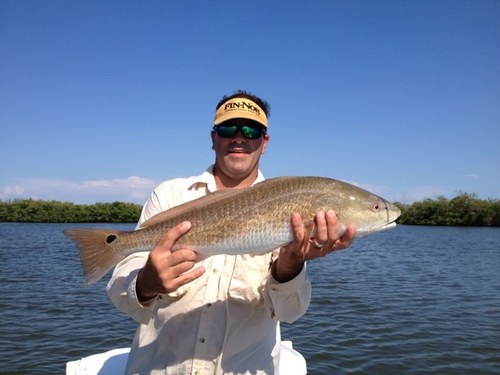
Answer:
[107,166,311,375]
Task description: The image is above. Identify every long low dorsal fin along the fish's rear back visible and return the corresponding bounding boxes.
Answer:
[140,188,246,229]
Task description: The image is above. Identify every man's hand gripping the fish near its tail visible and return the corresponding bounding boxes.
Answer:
[136,221,205,302]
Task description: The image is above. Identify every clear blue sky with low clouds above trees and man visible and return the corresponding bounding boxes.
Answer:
[0,0,500,203]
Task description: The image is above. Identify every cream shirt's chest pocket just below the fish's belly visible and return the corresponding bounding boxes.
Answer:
[228,253,272,305]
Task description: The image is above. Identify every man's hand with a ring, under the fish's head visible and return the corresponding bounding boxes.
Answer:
[272,210,356,282]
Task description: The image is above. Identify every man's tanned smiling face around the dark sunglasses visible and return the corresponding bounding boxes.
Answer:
[211,119,269,180]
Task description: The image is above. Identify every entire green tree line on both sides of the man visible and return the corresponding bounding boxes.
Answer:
[0,193,500,227]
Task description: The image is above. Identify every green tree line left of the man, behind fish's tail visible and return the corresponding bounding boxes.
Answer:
[0,199,142,223]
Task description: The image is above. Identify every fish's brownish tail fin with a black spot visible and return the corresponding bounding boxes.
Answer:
[64,229,123,285]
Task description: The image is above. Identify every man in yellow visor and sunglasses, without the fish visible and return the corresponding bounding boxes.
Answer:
[108,91,355,374]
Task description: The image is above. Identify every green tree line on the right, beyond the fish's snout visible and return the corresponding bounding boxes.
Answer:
[396,193,500,227]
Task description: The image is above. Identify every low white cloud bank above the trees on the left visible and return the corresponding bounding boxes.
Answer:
[0,176,157,204]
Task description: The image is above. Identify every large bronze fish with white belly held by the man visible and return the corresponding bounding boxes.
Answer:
[65,177,400,283]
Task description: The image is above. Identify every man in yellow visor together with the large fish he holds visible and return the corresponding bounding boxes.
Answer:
[64,91,401,374]
